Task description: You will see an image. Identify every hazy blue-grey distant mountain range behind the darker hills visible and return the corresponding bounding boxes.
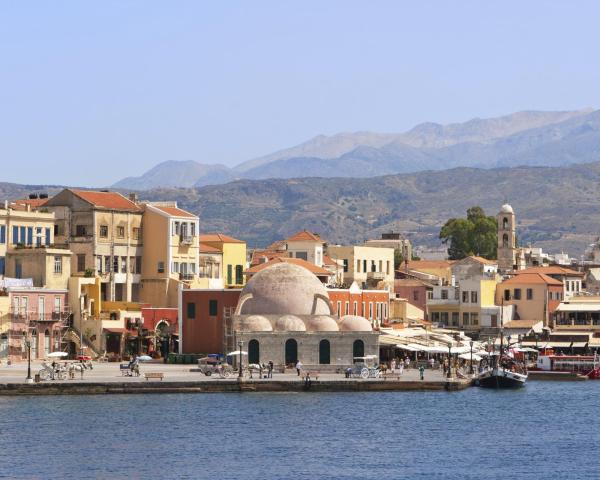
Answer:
[113,109,600,190]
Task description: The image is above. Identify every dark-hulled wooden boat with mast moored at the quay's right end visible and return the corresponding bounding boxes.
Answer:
[476,332,527,388]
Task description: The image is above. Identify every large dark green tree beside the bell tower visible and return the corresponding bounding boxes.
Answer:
[440,207,498,260]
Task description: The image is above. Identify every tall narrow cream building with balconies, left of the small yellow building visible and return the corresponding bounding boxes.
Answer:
[140,202,200,307]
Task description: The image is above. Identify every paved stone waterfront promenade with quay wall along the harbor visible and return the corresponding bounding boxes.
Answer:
[0,362,469,395]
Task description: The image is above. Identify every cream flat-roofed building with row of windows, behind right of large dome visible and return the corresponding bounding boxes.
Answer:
[327,245,394,288]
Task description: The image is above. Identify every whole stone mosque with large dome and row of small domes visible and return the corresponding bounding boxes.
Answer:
[233,262,379,371]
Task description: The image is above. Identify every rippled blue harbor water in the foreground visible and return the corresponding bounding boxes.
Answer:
[0,381,600,480]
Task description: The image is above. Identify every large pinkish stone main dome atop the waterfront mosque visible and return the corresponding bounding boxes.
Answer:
[239,263,331,315]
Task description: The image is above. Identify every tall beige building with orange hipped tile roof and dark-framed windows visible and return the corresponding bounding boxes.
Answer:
[45,189,143,302]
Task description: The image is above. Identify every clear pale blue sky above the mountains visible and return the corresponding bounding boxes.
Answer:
[0,0,600,187]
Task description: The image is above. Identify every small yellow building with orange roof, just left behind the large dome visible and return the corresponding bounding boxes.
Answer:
[200,233,246,288]
